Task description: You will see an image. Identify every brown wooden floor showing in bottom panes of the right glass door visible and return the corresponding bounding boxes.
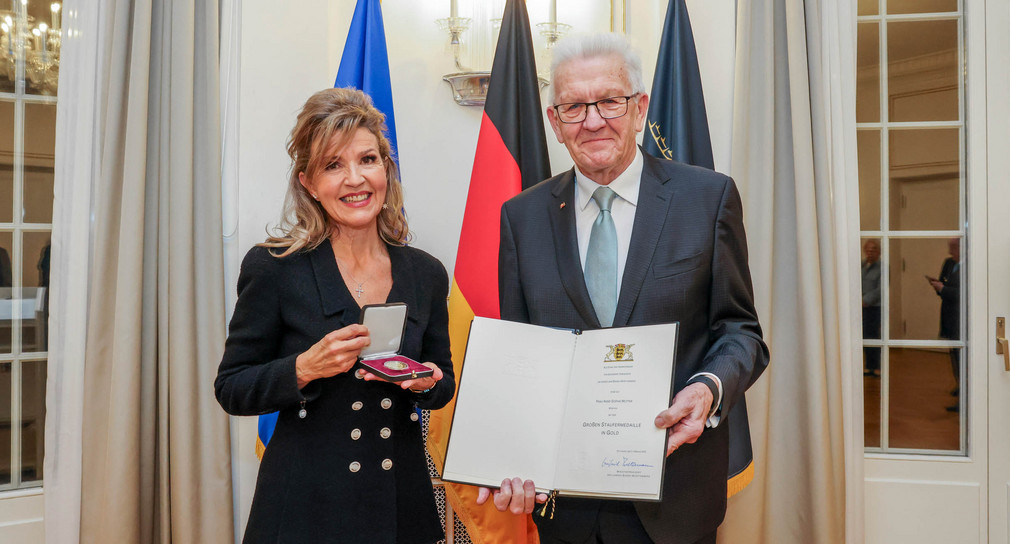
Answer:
[863,348,961,451]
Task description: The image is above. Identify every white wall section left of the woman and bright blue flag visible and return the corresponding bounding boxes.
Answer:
[225,0,331,542]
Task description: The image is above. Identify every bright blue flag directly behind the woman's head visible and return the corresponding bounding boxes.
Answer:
[257,0,400,457]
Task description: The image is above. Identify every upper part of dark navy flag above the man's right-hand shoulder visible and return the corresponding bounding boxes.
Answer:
[642,0,715,170]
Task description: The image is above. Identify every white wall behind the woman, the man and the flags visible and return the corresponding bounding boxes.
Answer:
[226,0,735,538]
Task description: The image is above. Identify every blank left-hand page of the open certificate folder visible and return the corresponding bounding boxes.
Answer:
[442,317,575,487]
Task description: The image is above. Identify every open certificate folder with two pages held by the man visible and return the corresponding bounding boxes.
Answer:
[442,317,677,501]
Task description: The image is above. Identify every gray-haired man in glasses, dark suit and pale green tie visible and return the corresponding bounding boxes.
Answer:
[478,34,769,544]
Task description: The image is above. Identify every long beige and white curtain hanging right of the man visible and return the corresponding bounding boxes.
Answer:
[719,0,863,544]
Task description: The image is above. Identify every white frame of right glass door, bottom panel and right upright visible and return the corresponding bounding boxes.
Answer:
[865,0,993,544]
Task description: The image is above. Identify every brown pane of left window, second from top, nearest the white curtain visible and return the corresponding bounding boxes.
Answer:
[24,104,57,223]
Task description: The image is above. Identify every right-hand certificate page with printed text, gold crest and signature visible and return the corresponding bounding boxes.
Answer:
[556,323,677,500]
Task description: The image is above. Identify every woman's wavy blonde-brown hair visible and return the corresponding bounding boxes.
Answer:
[260,89,410,257]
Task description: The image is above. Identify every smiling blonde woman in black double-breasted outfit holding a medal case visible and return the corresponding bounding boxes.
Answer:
[214,89,455,544]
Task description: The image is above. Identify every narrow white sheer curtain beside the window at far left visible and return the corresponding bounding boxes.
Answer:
[43,0,102,543]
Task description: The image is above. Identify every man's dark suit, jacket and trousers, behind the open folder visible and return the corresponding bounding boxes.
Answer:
[498,154,768,544]
